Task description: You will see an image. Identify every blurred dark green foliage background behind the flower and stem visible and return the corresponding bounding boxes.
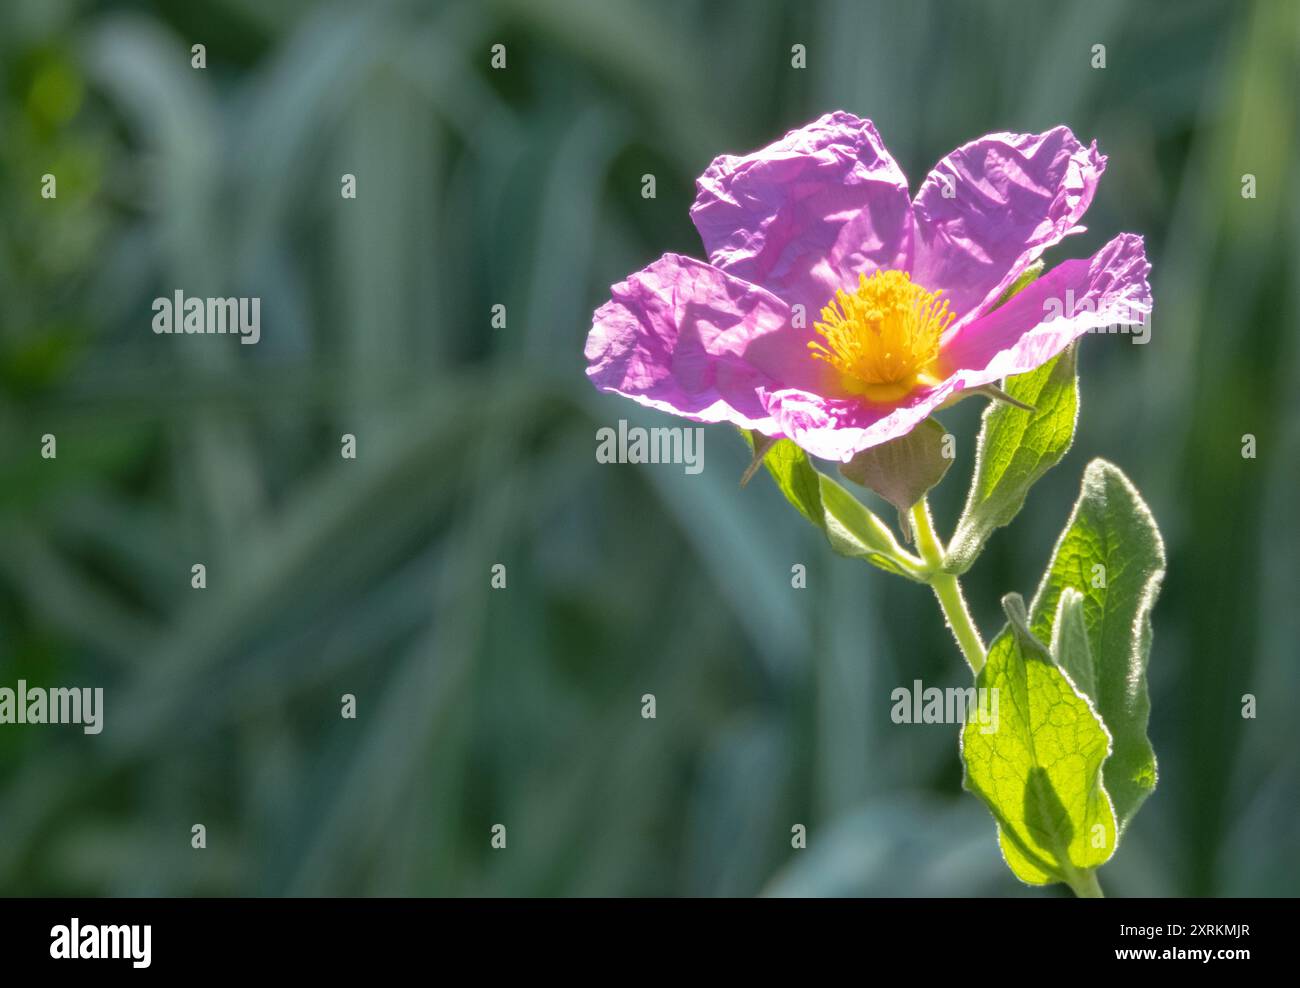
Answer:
[0,0,1300,896]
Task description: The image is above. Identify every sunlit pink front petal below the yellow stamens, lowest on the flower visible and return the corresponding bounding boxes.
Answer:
[764,378,961,463]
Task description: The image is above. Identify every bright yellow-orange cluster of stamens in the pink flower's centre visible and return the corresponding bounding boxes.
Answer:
[809,270,954,402]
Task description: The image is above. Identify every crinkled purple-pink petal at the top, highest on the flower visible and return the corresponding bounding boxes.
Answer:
[690,112,913,324]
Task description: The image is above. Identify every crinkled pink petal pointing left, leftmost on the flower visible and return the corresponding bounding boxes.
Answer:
[585,254,795,434]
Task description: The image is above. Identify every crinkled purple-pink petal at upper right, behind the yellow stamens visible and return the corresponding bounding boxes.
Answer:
[911,127,1106,332]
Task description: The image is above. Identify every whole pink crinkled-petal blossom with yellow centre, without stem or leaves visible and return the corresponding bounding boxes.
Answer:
[585,112,1151,462]
